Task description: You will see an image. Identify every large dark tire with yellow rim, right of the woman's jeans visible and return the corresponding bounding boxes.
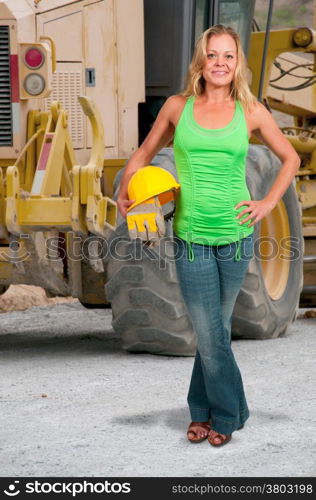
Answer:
[232,145,304,339]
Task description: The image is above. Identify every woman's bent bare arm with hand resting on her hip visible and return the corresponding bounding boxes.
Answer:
[235,102,300,227]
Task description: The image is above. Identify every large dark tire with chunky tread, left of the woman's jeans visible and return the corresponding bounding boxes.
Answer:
[105,148,196,356]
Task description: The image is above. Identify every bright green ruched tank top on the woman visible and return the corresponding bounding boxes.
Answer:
[173,96,254,261]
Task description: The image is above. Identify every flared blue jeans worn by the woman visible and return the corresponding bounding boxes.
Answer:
[174,233,254,434]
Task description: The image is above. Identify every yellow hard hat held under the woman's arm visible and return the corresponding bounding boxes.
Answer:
[127,165,180,210]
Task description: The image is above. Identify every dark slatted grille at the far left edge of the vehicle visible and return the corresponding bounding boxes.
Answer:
[0,26,12,147]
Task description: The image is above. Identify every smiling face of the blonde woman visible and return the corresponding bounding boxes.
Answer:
[202,33,237,87]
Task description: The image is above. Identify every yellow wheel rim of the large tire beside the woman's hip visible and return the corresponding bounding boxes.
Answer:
[260,200,291,300]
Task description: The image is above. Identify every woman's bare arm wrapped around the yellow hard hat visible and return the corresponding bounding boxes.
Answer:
[117,96,184,217]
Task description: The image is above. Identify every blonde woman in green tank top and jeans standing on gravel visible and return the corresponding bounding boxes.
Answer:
[117,25,300,446]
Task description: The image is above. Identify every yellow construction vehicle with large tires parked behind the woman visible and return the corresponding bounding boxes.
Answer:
[0,0,316,355]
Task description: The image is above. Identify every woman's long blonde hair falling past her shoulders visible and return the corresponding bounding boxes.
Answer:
[180,24,257,109]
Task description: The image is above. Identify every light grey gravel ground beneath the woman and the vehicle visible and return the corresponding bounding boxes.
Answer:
[0,303,316,477]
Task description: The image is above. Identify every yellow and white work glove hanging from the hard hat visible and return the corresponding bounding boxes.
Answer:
[126,196,166,246]
